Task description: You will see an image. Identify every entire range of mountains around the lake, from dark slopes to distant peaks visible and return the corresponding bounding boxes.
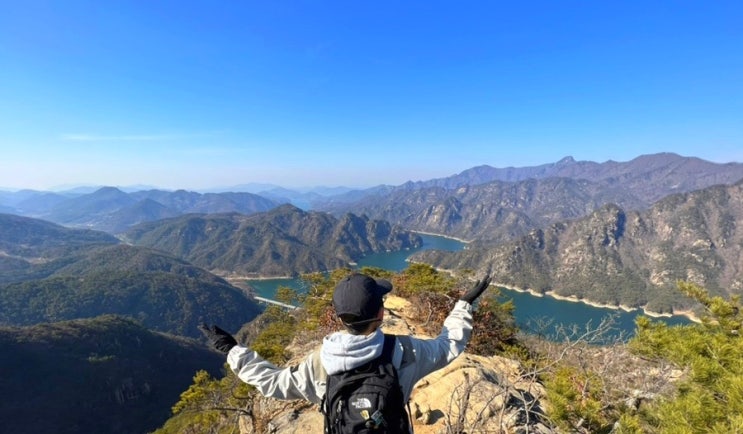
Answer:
[0,154,743,432]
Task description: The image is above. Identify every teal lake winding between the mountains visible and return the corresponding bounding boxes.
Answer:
[244,234,691,337]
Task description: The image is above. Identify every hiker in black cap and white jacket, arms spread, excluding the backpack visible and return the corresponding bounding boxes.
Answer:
[200,273,490,430]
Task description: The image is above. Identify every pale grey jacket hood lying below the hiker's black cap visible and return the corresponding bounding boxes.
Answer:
[320,329,384,375]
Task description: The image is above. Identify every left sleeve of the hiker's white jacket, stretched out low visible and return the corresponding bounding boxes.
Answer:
[227,345,326,403]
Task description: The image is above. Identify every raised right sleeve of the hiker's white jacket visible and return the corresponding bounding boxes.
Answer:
[400,300,472,397]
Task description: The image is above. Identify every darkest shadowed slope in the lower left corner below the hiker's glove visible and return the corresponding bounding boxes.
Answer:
[0,316,224,434]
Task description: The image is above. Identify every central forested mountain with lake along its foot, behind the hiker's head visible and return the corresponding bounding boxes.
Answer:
[122,205,421,276]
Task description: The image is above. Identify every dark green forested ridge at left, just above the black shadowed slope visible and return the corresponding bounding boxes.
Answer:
[0,246,261,337]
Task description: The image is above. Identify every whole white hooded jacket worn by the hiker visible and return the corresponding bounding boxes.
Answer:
[227,300,472,404]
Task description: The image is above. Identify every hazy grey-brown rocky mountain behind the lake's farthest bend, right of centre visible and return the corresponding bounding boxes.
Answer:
[322,178,641,243]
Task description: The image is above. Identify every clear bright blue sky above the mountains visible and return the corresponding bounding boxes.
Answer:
[0,0,743,190]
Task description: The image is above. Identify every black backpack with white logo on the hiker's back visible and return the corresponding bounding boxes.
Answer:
[321,335,410,434]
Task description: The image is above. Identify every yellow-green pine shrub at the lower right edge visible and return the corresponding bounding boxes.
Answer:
[630,282,743,433]
